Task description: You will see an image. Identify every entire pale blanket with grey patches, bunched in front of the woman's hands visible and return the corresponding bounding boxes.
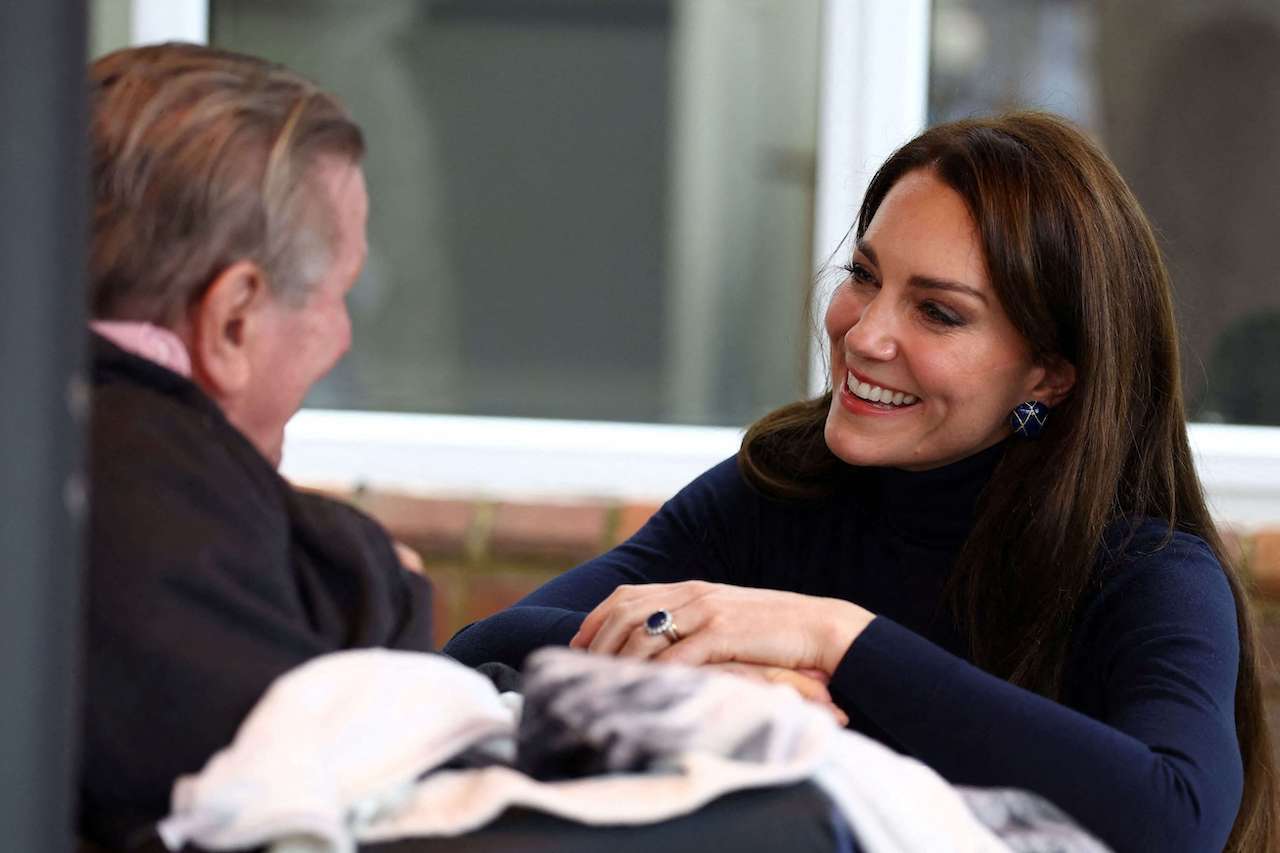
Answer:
[160,648,1093,853]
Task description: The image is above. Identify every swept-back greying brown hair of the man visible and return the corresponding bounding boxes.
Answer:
[90,44,365,325]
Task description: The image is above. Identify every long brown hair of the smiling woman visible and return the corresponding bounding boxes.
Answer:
[739,113,1280,853]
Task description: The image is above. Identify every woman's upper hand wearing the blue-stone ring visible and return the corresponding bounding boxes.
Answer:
[570,580,874,676]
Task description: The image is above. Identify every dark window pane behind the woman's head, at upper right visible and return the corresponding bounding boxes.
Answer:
[929,0,1280,425]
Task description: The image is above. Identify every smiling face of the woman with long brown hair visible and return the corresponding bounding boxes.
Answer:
[826,169,1074,470]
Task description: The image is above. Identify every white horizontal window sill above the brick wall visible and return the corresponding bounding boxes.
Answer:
[283,409,1280,528]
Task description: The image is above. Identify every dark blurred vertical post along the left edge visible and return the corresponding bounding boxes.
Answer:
[0,0,88,852]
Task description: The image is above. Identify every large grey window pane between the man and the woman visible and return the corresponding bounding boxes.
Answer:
[210,0,819,424]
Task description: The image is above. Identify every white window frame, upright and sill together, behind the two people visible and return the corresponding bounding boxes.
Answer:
[131,0,1280,526]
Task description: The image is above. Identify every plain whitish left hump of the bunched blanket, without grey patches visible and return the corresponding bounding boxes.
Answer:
[157,649,516,853]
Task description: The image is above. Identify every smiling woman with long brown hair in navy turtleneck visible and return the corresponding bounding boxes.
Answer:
[447,113,1274,850]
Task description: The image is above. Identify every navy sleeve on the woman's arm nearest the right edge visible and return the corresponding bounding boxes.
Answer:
[832,535,1243,853]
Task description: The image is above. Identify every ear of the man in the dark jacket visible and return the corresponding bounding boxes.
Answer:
[189,260,266,398]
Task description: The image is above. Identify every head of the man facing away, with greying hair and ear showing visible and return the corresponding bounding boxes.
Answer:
[90,45,367,461]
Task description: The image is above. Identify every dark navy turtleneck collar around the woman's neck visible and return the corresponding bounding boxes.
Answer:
[864,439,1009,548]
